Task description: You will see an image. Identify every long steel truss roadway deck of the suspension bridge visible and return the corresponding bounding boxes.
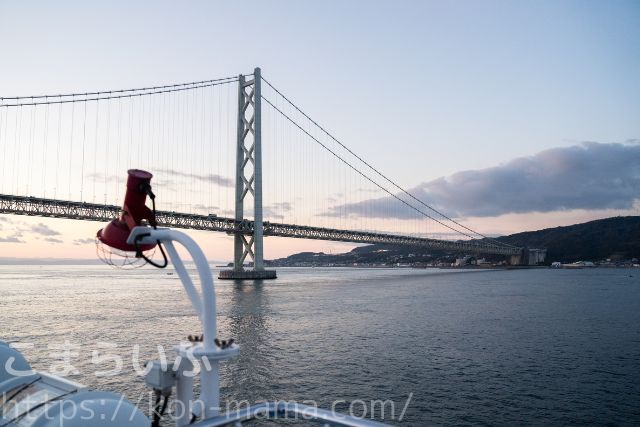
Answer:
[0,194,522,255]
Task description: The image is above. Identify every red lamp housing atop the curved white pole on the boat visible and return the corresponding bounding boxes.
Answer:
[96,169,156,252]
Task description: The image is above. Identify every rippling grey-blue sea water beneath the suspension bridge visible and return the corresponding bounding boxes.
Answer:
[0,265,640,426]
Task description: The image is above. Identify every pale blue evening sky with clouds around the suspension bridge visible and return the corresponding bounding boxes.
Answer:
[0,0,640,260]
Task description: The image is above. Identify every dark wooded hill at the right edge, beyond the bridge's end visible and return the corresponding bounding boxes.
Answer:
[498,216,640,262]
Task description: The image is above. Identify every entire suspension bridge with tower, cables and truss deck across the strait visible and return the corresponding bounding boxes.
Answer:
[0,68,525,278]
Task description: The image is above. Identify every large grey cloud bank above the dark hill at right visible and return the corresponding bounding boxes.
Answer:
[326,140,640,219]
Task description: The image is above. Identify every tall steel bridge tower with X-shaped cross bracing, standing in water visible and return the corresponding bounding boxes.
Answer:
[219,68,276,279]
